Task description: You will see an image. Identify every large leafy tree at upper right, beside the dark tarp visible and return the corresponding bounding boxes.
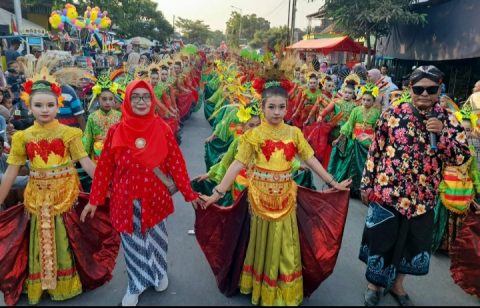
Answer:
[309,0,427,66]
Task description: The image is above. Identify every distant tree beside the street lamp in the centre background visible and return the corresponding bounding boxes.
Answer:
[226,12,270,46]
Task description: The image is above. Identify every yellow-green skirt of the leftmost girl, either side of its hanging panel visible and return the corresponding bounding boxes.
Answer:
[25,215,82,305]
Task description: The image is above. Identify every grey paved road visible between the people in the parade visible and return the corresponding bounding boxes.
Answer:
[0,107,480,306]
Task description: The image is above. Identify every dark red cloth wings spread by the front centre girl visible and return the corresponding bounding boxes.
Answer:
[195,187,349,297]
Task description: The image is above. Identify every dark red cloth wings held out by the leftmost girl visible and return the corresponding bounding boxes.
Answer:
[0,193,120,306]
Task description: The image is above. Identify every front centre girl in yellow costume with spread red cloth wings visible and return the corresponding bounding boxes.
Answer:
[195,75,350,306]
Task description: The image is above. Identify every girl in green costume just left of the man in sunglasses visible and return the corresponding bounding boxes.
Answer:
[328,83,380,196]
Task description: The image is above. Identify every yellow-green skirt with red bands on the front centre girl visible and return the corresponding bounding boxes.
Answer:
[240,211,303,306]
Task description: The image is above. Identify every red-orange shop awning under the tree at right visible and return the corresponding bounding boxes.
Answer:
[287,36,368,55]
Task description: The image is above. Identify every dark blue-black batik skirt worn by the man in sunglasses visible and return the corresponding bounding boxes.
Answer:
[359,202,434,292]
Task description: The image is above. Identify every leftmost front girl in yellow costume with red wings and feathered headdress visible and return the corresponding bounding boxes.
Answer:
[0,69,119,305]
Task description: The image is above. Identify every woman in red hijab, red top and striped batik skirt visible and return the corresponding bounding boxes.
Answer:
[81,80,199,306]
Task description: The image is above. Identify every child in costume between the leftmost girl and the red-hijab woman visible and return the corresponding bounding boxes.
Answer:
[82,75,122,163]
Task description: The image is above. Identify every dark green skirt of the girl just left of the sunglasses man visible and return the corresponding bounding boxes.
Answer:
[328,138,368,196]
